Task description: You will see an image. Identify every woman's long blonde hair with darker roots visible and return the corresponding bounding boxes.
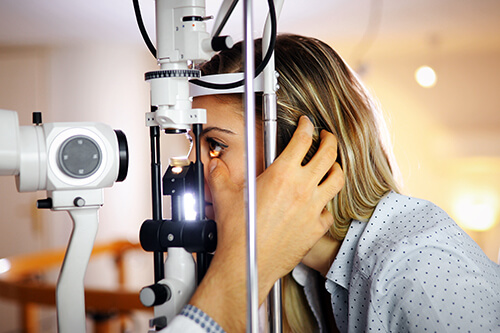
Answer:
[201,34,398,332]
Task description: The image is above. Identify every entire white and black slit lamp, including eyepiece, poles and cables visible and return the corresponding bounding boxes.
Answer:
[0,0,283,333]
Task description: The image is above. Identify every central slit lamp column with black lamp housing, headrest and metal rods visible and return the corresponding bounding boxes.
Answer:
[134,0,283,332]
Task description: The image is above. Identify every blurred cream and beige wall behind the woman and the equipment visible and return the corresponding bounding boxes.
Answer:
[0,0,500,333]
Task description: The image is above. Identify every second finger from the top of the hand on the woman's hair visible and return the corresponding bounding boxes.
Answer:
[306,130,337,184]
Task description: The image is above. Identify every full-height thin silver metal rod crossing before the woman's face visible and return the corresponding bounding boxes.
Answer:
[243,0,259,333]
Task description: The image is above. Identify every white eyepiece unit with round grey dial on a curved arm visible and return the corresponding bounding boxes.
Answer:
[0,110,128,333]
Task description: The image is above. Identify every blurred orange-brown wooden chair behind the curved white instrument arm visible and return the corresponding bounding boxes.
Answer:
[0,241,146,333]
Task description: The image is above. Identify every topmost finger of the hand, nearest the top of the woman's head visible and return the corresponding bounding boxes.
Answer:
[278,116,314,163]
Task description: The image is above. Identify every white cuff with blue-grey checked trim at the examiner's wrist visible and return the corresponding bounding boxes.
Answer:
[160,304,225,333]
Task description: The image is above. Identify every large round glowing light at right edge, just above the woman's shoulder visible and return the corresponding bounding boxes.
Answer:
[454,191,499,231]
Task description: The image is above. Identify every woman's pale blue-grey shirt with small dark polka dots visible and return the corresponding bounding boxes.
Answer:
[326,192,500,332]
